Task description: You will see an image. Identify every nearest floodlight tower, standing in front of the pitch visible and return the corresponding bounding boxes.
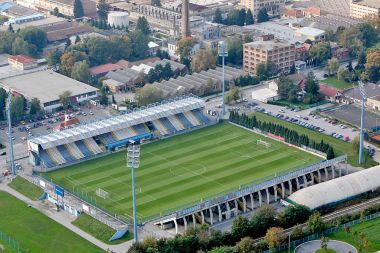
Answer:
[127,141,140,242]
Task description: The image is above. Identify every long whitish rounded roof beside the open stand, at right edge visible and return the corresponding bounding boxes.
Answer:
[288,165,380,209]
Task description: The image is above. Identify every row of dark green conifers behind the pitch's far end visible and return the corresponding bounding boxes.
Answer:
[230,111,335,160]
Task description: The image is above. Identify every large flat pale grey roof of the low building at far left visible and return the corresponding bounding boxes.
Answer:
[0,70,98,103]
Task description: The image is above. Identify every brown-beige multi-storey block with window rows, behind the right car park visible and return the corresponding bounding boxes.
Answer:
[243,36,296,75]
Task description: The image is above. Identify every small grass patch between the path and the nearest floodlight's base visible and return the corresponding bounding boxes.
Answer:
[72,213,133,244]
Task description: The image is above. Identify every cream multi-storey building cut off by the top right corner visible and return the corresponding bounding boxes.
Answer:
[350,0,380,19]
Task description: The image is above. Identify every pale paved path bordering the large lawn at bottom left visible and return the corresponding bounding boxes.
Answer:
[0,183,133,253]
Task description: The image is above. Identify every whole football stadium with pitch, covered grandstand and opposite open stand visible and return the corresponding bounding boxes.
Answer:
[28,96,346,232]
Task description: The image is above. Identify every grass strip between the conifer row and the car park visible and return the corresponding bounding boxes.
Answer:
[254,112,377,168]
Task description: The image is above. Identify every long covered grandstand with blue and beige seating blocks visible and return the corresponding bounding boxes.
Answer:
[28,96,210,169]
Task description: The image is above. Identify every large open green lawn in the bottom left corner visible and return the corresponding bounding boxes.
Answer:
[0,191,103,253]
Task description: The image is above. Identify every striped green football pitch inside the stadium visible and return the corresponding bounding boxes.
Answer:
[45,123,321,220]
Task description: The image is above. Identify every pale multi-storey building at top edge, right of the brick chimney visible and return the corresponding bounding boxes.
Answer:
[240,0,285,18]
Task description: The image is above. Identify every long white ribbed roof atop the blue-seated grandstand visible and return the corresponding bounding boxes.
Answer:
[28,96,204,149]
